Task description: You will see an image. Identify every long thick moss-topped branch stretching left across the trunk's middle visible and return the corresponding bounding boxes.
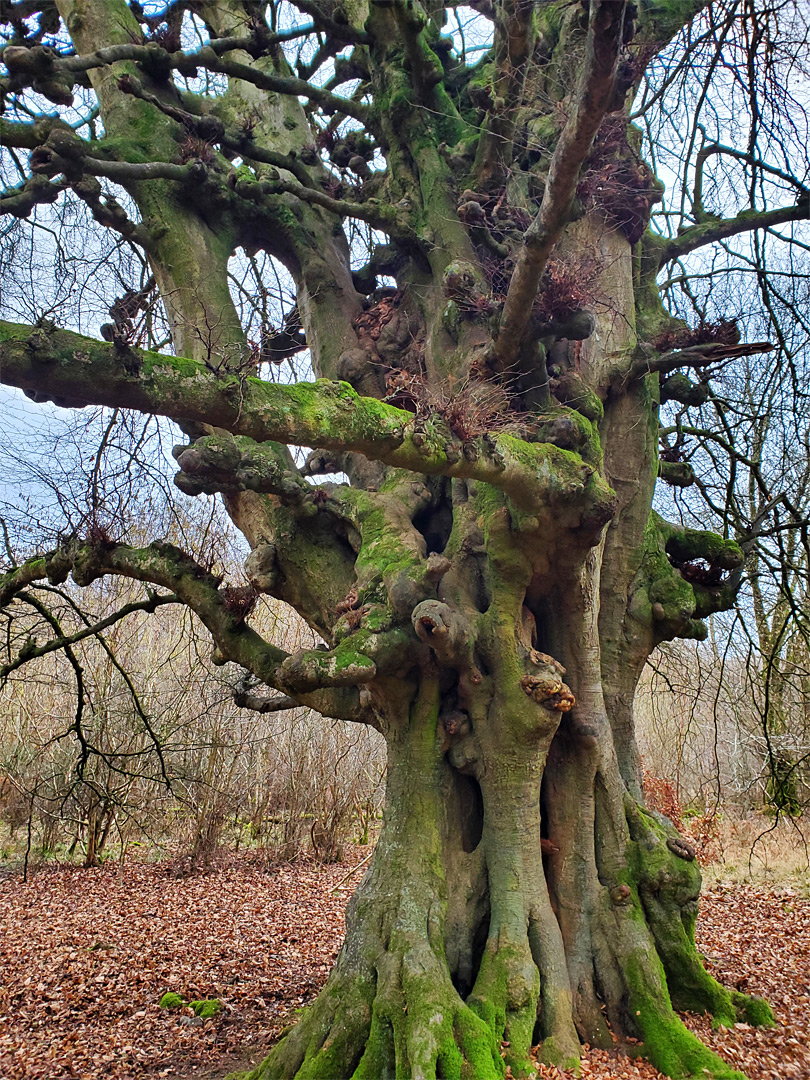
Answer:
[0,322,612,513]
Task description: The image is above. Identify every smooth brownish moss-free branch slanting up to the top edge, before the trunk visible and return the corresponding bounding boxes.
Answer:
[495,0,625,369]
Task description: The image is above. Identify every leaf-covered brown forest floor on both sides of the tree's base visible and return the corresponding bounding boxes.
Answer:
[0,848,810,1080]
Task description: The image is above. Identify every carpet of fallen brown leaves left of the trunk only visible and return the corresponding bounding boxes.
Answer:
[0,851,364,1080]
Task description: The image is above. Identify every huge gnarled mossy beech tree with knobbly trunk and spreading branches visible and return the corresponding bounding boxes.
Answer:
[0,0,809,1080]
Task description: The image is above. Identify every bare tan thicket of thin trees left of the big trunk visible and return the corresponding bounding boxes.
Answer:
[0,501,384,873]
